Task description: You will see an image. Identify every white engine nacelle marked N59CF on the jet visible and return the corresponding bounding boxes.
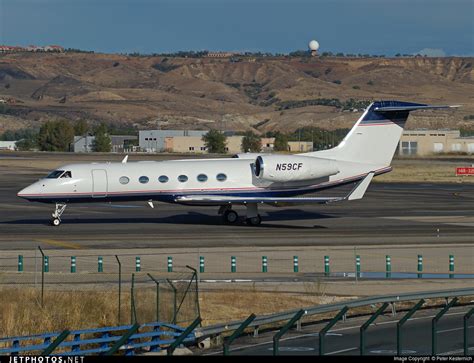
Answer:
[254,155,339,182]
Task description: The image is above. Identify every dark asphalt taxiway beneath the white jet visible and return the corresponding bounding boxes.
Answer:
[0,167,474,250]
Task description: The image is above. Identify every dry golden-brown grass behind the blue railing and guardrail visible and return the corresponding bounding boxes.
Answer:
[0,285,352,337]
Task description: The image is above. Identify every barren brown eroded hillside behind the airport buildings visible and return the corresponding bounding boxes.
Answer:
[0,53,474,132]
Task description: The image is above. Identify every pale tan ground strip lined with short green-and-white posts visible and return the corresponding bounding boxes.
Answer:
[0,245,474,283]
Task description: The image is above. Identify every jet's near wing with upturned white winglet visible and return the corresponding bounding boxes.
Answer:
[175,172,374,205]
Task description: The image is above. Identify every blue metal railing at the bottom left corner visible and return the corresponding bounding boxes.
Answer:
[0,322,196,356]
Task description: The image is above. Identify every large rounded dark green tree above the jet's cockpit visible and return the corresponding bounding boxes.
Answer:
[38,120,74,151]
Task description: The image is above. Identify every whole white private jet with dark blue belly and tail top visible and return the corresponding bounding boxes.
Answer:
[18,101,456,226]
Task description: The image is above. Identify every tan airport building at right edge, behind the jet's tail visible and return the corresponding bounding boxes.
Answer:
[398,130,474,156]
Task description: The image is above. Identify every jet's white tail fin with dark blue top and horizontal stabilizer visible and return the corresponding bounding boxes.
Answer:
[306,101,459,166]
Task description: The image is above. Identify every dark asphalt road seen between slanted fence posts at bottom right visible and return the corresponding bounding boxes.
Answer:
[202,307,474,355]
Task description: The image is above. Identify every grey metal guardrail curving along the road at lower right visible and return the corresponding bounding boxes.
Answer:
[195,288,474,339]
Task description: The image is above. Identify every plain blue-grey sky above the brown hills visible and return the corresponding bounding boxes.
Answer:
[0,0,474,56]
